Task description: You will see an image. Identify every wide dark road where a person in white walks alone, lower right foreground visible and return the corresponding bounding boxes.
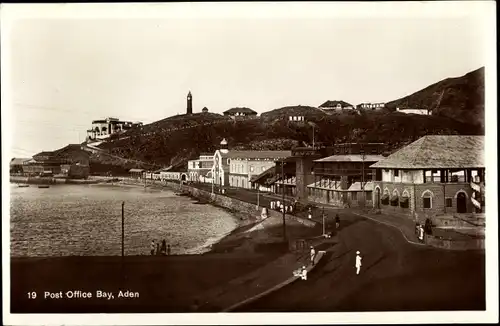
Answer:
[240,212,486,312]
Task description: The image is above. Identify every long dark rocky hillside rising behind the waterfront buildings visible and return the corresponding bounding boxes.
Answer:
[90,68,484,171]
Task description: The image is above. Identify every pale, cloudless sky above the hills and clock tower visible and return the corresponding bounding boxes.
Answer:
[2,3,487,157]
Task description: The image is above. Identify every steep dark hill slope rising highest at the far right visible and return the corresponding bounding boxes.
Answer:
[386,67,484,128]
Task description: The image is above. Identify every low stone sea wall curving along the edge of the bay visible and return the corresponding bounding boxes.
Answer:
[165,181,318,228]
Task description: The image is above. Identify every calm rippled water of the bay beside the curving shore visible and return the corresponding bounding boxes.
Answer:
[10,184,237,257]
